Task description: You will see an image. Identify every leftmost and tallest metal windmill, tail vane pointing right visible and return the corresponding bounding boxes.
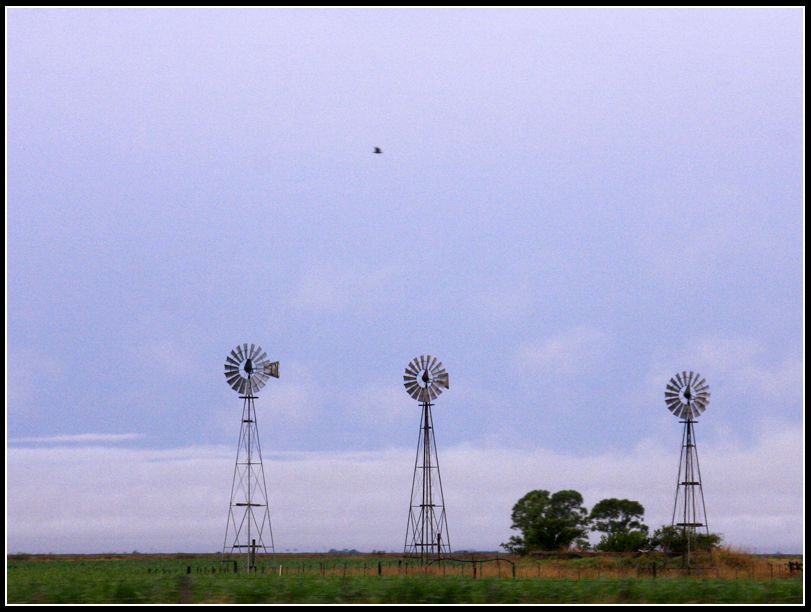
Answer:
[222,344,279,571]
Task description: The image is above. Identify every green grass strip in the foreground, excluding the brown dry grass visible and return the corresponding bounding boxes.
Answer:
[7,559,803,603]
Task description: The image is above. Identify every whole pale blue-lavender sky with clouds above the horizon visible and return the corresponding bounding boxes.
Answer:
[6,8,805,552]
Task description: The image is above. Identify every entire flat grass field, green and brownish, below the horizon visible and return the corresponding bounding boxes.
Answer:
[6,555,803,603]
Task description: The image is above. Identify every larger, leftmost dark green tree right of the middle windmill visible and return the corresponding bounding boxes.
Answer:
[501,489,588,555]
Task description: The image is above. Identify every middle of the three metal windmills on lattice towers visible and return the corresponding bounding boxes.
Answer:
[403,355,451,560]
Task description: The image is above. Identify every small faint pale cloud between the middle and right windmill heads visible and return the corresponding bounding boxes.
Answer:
[515,325,610,376]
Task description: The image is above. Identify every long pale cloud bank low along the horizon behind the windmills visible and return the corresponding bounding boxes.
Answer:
[7,427,803,552]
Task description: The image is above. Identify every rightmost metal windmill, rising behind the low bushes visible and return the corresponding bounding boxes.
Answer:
[665,372,710,568]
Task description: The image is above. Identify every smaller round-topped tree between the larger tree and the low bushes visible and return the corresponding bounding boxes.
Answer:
[589,497,648,552]
